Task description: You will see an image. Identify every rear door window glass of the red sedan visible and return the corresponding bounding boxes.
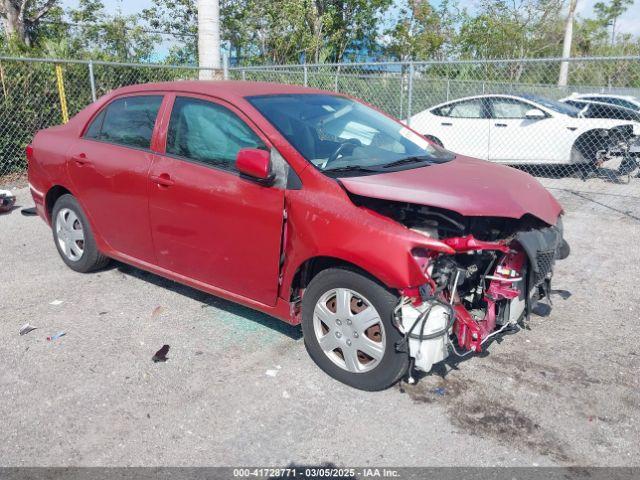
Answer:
[85,95,162,148]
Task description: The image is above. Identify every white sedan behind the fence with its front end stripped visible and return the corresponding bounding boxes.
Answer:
[409,94,640,166]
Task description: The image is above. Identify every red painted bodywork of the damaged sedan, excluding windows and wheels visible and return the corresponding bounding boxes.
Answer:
[29,82,561,323]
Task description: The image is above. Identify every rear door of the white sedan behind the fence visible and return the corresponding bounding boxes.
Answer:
[427,98,489,160]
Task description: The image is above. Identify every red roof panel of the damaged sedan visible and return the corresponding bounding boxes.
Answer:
[111,80,336,100]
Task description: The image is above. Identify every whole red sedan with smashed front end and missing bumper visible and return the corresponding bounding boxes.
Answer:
[27,82,568,390]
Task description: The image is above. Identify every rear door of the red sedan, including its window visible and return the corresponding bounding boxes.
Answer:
[68,94,163,263]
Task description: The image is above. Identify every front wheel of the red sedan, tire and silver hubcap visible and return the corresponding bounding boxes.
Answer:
[302,268,409,391]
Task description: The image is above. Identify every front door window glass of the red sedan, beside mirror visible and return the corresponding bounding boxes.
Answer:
[167,97,265,170]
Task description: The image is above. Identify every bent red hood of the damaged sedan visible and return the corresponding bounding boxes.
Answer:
[340,156,562,225]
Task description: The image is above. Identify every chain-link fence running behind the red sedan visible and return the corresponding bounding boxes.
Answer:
[0,57,640,199]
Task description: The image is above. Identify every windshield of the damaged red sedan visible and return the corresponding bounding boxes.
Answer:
[247,94,454,174]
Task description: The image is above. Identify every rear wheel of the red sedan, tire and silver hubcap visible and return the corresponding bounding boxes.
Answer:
[51,194,109,273]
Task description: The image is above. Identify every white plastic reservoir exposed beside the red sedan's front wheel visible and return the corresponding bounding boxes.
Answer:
[401,303,449,372]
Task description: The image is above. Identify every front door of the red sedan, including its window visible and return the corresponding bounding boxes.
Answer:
[149,94,284,305]
